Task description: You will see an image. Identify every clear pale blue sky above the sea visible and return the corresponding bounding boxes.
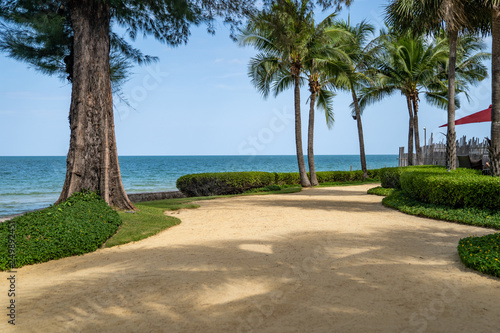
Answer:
[0,0,491,156]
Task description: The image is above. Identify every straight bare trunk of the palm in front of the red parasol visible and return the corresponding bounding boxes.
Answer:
[446,30,458,170]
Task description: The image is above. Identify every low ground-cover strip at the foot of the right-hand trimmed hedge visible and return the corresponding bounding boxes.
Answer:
[382,190,500,229]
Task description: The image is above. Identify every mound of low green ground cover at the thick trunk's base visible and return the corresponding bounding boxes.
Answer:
[0,192,121,270]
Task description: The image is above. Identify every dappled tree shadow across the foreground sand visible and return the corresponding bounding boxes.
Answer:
[14,224,500,332]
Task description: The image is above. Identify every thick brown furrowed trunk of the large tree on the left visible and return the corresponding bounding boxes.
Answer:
[57,0,135,209]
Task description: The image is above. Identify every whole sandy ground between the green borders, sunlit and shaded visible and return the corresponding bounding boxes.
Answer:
[0,186,500,333]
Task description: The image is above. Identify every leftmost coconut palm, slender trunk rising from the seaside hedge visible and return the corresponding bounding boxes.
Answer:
[238,0,313,187]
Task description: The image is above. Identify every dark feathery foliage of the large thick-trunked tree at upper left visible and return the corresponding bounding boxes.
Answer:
[0,0,255,87]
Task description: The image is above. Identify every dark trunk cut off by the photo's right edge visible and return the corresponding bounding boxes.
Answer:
[490,6,500,177]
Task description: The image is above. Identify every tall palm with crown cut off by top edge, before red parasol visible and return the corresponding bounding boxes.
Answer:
[386,0,490,169]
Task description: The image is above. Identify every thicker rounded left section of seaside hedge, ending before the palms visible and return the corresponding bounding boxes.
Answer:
[177,172,275,197]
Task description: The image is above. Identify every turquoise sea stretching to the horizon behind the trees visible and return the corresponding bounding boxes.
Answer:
[0,155,398,216]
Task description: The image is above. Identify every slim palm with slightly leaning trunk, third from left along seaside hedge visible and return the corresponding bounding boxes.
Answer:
[328,19,377,178]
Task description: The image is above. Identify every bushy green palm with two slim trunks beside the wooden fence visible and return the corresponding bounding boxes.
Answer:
[360,30,447,165]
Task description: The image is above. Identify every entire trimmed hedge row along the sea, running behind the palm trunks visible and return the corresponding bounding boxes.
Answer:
[177,170,379,197]
